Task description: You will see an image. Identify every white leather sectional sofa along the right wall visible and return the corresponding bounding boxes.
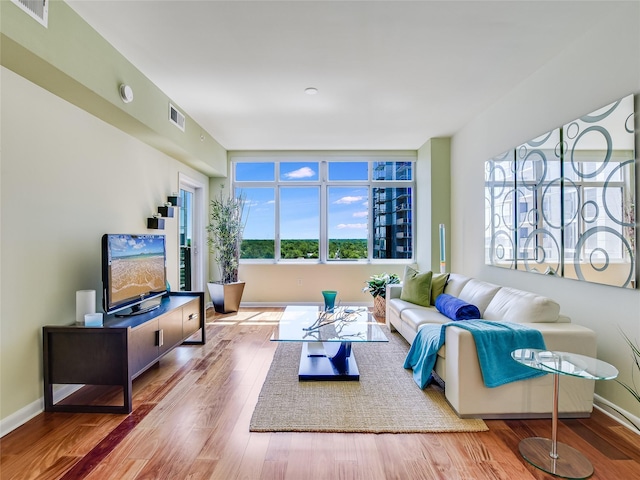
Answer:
[386,273,596,419]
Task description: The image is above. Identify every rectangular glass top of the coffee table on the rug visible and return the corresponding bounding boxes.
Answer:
[271,305,389,342]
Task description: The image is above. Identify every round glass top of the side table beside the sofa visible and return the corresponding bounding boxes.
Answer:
[511,348,618,380]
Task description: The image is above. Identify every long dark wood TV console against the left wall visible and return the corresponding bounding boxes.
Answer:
[42,292,206,413]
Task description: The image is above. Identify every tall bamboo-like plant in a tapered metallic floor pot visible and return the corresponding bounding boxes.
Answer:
[207,192,245,313]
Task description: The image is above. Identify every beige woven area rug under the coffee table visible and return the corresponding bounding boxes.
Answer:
[250,328,488,433]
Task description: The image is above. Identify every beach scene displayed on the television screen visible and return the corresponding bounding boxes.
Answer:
[109,235,166,303]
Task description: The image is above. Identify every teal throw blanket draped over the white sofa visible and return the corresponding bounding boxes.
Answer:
[404,320,546,388]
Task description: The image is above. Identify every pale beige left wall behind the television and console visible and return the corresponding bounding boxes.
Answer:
[0,67,208,428]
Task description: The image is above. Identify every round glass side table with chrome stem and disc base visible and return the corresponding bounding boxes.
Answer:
[511,348,618,479]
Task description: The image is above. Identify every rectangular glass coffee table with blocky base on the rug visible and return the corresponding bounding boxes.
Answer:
[271,306,389,381]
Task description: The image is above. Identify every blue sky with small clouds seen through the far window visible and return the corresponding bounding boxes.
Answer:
[236,162,369,239]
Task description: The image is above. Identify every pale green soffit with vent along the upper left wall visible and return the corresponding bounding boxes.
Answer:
[0,0,227,177]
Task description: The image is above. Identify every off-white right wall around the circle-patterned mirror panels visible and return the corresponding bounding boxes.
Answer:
[451,2,640,416]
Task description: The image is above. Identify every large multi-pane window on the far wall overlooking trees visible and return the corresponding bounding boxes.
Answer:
[231,154,415,263]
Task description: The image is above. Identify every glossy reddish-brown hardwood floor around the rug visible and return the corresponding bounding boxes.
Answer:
[0,308,640,480]
